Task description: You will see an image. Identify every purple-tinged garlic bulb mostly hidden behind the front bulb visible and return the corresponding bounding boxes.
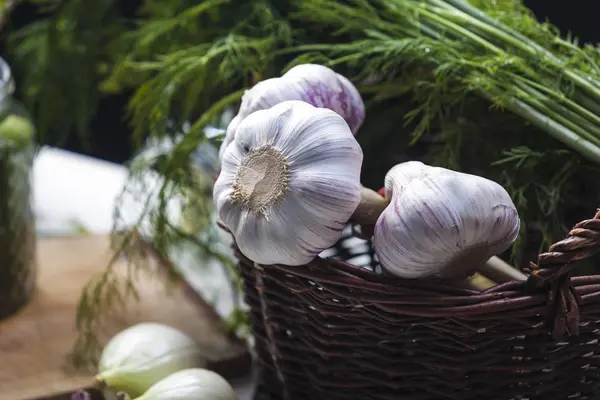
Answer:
[219,64,365,159]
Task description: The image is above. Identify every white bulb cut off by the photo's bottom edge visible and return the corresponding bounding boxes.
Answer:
[129,368,237,400]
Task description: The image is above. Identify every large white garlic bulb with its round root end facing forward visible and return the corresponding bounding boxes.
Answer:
[213,101,363,265]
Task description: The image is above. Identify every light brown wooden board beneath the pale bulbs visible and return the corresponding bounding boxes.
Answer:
[0,236,250,400]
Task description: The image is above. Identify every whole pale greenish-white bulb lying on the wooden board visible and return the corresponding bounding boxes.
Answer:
[96,322,204,396]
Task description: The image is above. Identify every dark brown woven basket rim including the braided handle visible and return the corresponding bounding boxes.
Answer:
[217,209,600,339]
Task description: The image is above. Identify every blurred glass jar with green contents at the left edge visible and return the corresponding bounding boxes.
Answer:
[0,58,37,319]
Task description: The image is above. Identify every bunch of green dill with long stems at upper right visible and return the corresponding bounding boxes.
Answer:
[295,0,600,163]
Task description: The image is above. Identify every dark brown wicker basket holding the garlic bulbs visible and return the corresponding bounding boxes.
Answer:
[223,211,600,400]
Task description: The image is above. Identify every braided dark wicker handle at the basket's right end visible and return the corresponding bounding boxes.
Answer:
[526,209,600,340]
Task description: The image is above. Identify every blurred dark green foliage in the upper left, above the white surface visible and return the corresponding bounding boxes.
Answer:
[7,0,125,146]
